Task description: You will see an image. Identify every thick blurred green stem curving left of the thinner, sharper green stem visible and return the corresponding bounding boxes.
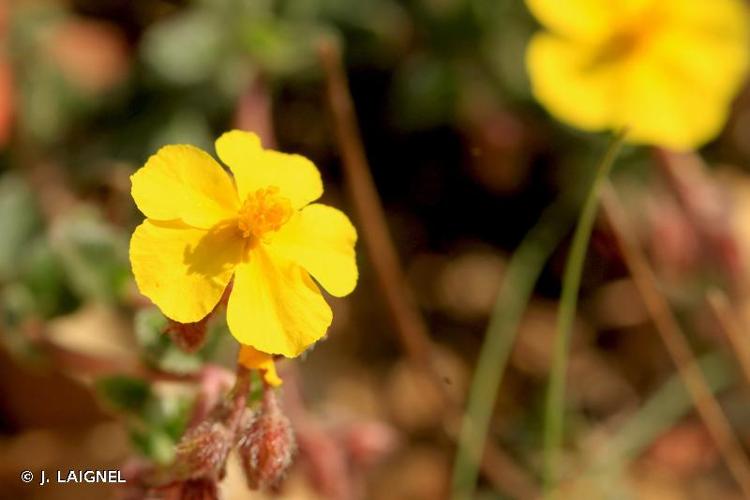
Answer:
[452,201,572,500]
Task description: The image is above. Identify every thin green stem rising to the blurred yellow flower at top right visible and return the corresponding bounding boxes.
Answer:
[544,131,625,490]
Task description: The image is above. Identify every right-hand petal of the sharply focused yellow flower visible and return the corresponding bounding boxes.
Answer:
[271,203,358,297]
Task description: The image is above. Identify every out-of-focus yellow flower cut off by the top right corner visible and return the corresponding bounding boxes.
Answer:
[526,0,750,149]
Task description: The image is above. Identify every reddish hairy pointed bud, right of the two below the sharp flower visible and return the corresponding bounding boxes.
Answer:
[238,387,296,489]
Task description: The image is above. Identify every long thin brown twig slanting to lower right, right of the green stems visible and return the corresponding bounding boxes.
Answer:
[602,183,750,498]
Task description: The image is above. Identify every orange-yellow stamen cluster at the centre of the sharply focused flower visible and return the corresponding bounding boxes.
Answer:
[237,186,293,242]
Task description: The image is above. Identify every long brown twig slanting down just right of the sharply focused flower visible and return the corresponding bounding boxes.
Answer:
[319,40,538,498]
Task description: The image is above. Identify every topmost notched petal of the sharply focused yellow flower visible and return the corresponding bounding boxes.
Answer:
[216,130,323,208]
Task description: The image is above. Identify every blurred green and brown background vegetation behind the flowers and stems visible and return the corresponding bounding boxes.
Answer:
[0,0,750,500]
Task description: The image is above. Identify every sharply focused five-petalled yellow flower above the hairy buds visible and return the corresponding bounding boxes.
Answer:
[130,130,357,383]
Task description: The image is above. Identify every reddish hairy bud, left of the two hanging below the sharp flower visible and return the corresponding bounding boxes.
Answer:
[175,419,231,479]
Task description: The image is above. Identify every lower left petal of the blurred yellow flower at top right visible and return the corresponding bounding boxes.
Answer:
[526,33,622,131]
